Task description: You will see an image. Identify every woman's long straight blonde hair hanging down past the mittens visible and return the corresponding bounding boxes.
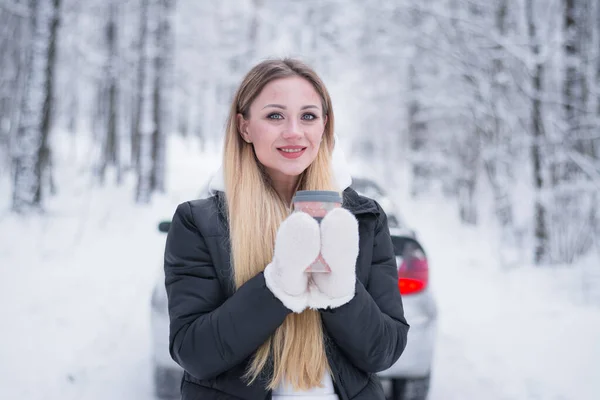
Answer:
[223,58,339,390]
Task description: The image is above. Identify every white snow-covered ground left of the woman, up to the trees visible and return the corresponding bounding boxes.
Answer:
[0,138,218,400]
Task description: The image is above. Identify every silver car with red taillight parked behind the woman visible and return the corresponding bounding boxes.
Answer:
[151,178,437,400]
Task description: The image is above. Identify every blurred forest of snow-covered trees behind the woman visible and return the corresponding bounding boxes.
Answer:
[0,0,600,265]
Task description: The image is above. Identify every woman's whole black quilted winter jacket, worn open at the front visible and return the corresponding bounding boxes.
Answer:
[165,188,409,400]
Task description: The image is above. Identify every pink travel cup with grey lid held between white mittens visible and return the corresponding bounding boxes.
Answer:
[292,190,342,273]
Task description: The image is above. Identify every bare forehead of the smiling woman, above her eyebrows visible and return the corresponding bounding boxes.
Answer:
[254,77,321,107]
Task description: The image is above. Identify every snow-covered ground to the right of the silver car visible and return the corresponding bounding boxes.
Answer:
[400,196,600,400]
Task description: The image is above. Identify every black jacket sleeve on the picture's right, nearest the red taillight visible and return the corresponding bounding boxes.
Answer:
[321,205,409,373]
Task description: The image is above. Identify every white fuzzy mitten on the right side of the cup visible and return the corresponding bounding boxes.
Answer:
[308,208,358,309]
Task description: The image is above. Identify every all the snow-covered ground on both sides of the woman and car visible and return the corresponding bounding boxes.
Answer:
[0,136,600,400]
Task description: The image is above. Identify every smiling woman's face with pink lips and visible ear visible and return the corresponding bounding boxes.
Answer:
[238,77,327,182]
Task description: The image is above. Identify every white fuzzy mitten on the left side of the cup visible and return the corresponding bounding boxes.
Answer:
[264,212,321,313]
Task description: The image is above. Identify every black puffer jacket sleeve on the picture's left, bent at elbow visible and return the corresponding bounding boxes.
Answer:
[164,203,290,379]
